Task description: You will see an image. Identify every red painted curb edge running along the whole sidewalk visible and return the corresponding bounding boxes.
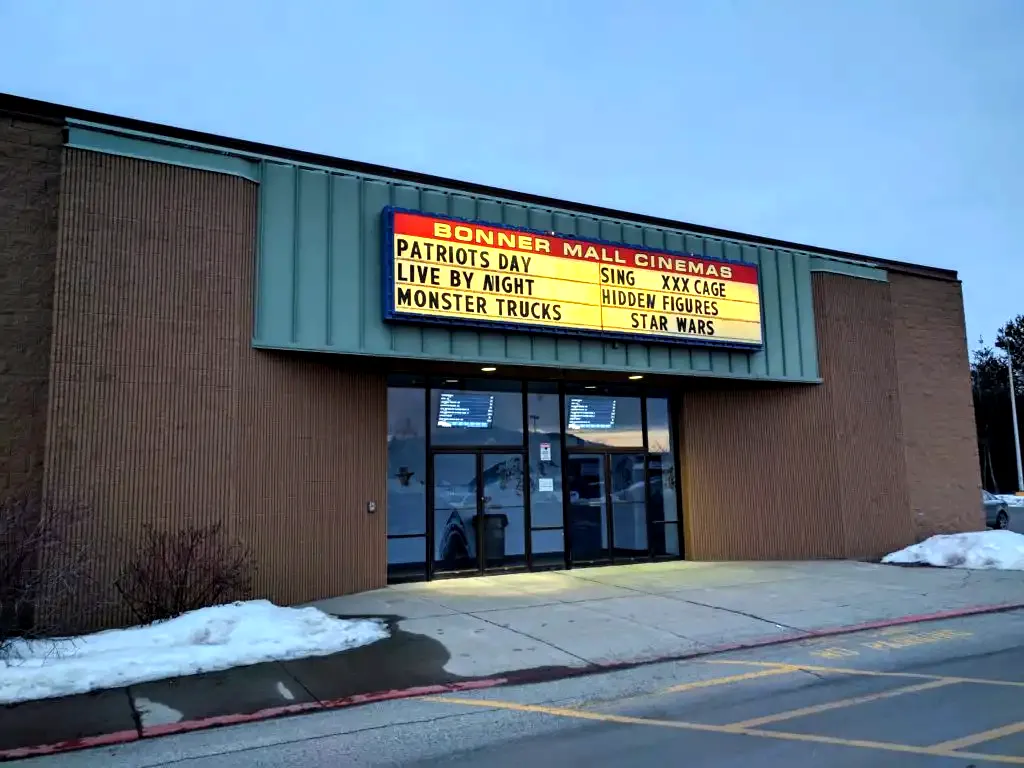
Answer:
[0,602,1024,762]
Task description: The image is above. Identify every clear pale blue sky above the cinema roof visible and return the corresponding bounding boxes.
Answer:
[0,0,1024,346]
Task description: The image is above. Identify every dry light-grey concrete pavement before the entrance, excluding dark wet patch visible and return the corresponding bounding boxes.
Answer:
[313,561,1024,677]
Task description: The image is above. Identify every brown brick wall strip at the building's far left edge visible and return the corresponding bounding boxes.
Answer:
[0,116,62,502]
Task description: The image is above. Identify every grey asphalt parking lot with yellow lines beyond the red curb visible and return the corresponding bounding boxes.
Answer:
[14,611,1024,768]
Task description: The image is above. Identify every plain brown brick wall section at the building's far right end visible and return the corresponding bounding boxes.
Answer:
[891,274,984,540]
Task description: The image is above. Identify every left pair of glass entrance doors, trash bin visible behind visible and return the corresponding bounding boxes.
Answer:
[432,452,526,573]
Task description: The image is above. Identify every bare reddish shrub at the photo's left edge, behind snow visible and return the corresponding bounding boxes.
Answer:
[0,498,89,657]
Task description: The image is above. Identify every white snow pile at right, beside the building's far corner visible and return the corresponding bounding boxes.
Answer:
[882,530,1024,570]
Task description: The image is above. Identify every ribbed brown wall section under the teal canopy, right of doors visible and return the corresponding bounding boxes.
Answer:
[682,387,843,560]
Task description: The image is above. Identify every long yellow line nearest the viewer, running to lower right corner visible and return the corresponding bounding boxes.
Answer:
[423,696,1024,765]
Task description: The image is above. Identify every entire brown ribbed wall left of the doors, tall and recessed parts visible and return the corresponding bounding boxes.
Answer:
[46,150,386,624]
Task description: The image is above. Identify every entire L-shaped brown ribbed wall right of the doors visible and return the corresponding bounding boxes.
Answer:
[681,273,912,559]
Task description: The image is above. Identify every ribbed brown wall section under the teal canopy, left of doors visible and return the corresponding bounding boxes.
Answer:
[238,353,387,603]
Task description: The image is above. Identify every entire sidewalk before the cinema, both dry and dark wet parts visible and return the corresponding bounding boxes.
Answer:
[0,561,1024,759]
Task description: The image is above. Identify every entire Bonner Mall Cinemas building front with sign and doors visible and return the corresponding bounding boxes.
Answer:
[0,96,982,621]
